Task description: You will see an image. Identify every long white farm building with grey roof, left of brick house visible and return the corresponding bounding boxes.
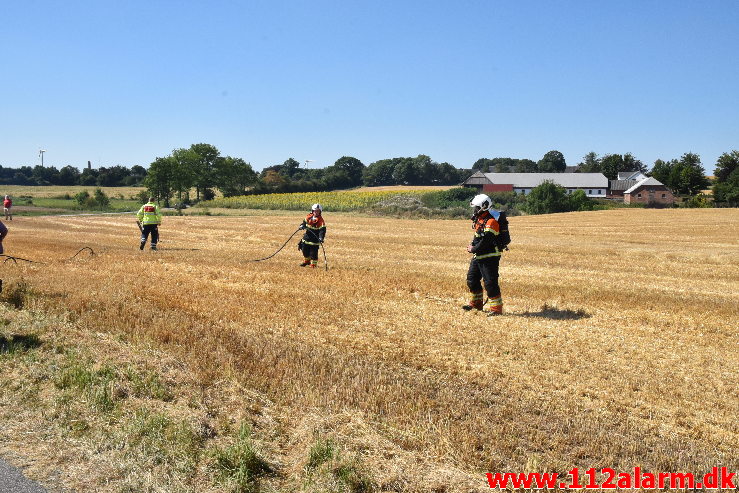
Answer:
[462,171,608,198]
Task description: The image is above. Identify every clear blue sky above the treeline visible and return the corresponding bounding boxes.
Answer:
[0,0,739,174]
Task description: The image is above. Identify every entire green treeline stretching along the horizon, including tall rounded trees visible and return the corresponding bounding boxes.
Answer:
[0,143,739,204]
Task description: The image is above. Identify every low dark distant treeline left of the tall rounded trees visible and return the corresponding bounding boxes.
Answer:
[0,166,146,187]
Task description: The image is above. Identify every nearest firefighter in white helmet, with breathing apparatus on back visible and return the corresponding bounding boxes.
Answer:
[462,194,503,315]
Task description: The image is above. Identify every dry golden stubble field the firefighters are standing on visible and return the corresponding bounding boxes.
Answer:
[2,209,739,491]
